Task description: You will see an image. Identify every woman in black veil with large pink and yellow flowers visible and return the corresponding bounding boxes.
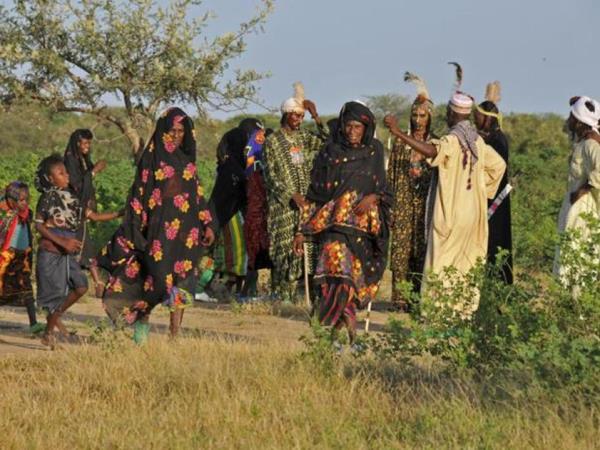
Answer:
[98,108,214,342]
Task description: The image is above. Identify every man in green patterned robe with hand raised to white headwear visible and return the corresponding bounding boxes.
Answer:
[263,86,327,302]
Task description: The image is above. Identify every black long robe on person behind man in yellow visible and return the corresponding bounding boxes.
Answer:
[483,130,513,284]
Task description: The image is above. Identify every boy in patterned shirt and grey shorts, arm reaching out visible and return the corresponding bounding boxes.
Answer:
[35,154,116,348]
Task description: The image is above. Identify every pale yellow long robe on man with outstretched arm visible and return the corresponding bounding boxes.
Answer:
[422,135,506,294]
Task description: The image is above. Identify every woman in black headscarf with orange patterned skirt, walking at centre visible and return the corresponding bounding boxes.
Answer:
[294,102,392,340]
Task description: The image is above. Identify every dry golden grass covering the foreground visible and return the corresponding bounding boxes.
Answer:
[0,335,600,449]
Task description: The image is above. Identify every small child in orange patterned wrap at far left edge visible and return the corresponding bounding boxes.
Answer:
[0,181,44,333]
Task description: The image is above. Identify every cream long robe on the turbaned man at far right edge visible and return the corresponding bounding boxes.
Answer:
[554,139,600,275]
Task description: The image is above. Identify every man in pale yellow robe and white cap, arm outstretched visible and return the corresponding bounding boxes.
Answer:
[385,92,506,309]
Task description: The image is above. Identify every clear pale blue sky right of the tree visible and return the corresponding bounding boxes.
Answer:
[202,0,600,115]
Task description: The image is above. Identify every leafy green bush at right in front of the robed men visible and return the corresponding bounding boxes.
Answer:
[372,219,600,399]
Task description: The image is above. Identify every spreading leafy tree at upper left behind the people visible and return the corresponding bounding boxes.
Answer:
[0,0,273,154]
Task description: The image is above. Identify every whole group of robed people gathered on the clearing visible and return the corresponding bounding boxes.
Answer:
[0,65,600,346]
